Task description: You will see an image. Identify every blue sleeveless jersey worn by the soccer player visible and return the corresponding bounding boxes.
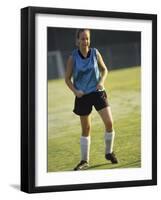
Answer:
[72,48,100,94]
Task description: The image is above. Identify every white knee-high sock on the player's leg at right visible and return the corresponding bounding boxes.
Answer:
[105,131,115,154]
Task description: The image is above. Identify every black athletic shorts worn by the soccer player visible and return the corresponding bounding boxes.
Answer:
[73,91,109,116]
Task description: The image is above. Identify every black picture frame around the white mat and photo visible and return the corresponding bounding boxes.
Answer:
[21,7,157,193]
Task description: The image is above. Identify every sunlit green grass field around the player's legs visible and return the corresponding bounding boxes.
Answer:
[48,67,141,172]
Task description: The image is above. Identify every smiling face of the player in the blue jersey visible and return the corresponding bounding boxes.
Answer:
[78,30,90,49]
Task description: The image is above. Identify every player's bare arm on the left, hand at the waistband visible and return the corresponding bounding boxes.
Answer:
[65,56,84,97]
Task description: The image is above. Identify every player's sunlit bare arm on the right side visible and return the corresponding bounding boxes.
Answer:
[97,51,108,90]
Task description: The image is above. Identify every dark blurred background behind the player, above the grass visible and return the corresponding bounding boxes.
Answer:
[47,27,141,80]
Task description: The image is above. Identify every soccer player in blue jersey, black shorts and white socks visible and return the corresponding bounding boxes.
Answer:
[65,29,118,170]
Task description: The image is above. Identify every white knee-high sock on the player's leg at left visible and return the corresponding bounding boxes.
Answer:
[80,136,91,162]
